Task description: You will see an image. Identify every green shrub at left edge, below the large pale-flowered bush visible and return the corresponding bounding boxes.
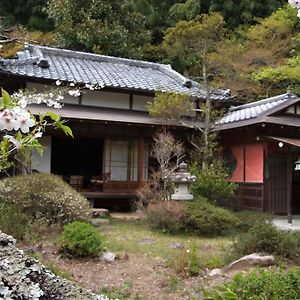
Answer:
[0,200,29,240]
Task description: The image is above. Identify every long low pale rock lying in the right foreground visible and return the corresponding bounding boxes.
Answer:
[225,253,275,272]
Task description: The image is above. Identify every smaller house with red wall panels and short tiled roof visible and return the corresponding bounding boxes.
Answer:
[217,93,300,217]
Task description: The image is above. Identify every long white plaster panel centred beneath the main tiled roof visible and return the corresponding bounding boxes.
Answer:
[82,91,130,109]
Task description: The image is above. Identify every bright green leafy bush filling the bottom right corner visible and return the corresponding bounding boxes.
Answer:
[205,269,300,300]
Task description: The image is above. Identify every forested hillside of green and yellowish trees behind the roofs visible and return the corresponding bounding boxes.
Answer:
[0,0,300,101]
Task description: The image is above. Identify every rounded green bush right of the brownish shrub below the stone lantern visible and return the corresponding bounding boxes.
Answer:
[183,197,239,235]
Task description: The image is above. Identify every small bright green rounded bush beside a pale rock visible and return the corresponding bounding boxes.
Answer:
[60,221,102,257]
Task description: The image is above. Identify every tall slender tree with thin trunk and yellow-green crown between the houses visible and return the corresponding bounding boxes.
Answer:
[156,13,225,168]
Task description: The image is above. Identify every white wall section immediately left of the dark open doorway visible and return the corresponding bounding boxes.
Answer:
[31,136,52,173]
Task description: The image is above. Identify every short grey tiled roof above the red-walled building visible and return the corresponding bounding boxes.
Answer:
[217,93,297,127]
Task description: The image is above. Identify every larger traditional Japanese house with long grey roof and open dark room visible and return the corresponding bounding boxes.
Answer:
[0,45,232,206]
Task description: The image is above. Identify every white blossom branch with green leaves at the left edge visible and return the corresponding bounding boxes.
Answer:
[0,89,73,172]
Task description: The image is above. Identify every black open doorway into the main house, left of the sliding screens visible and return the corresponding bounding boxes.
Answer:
[51,137,103,186]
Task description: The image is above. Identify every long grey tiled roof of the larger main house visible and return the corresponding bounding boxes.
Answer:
[0,45,231,100]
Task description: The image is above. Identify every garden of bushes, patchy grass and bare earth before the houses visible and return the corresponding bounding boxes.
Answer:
[0,170,300,299]
